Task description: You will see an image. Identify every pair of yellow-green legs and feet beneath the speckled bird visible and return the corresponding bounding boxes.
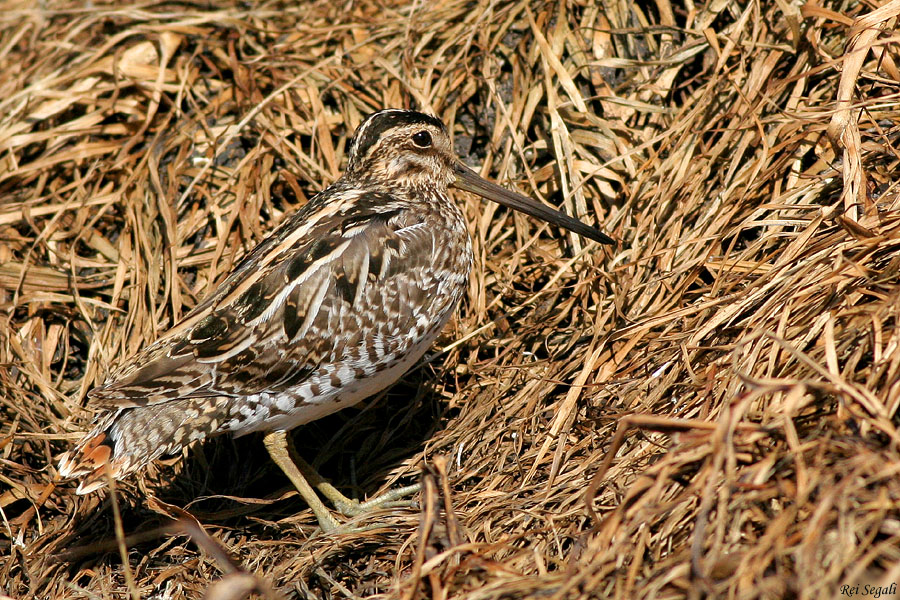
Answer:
[263,431,421,532]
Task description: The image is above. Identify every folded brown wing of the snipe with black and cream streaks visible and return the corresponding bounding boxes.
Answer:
[90,192,441,408]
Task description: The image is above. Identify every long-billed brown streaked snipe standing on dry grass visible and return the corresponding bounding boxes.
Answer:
[58,109,614,531]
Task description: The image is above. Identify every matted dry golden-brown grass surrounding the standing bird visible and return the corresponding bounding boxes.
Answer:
[0,0,900,600]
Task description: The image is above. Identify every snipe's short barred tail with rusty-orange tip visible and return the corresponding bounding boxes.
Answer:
[58,398,227,494]
